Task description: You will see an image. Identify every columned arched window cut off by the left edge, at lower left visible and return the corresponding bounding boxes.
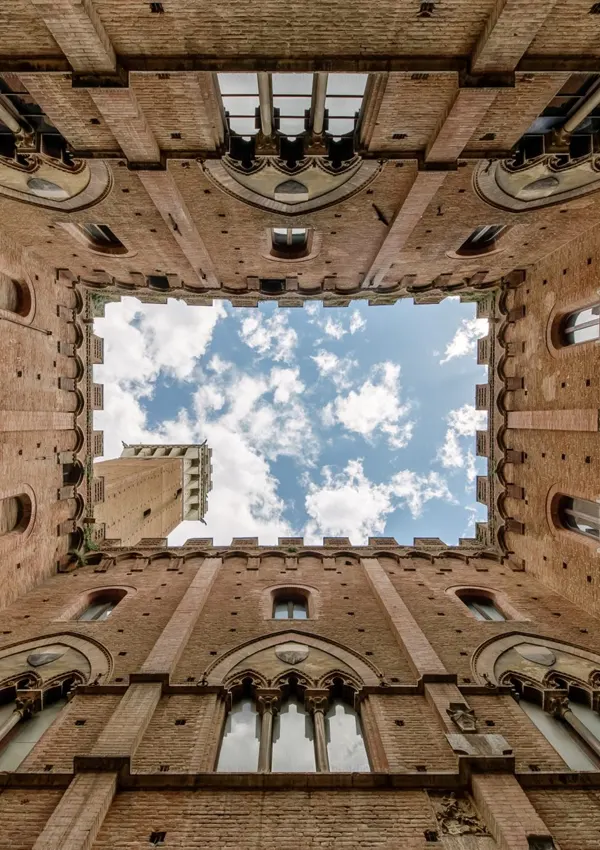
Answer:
[0,678,73,771]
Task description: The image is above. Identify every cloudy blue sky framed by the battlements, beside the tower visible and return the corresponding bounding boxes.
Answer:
[94,298,487,544]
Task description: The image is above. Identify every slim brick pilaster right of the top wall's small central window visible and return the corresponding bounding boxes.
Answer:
[365,171,447,286]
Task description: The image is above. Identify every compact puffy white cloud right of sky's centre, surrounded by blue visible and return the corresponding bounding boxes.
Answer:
[332,362,414,449]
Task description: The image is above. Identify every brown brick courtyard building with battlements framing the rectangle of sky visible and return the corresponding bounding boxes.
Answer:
[0,0,600,850]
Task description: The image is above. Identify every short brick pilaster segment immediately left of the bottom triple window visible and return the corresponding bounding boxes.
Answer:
[91,682,162,757]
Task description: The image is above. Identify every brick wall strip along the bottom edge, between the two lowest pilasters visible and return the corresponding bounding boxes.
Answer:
[92,791,435,850]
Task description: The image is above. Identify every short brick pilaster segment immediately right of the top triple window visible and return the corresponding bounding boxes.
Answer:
[425,88,498,162]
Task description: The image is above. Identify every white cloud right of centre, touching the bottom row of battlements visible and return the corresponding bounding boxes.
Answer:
[305,459,455,544]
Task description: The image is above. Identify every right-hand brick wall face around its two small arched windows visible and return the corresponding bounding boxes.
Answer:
[505,225,600,612]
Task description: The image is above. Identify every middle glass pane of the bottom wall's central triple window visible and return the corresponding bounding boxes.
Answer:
[272,697,317,773]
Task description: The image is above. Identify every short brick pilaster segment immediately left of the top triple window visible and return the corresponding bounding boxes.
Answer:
[89,88,160,163]
